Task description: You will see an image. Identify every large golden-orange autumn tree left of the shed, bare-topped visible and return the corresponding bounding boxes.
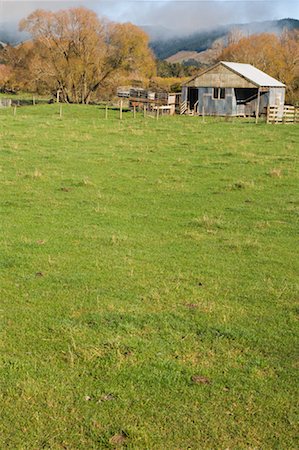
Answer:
[20,8,155,103]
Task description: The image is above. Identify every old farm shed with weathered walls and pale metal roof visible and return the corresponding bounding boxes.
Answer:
[181,61,285,116]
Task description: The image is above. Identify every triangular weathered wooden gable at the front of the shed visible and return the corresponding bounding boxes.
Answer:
[186,65,256,88]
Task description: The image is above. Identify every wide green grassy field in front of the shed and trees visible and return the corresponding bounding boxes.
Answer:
[0,105,299,450]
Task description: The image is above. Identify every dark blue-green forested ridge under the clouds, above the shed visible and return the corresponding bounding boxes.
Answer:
[151,19,299,59]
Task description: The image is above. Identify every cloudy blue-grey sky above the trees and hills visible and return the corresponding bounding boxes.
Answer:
[0,0,299,33]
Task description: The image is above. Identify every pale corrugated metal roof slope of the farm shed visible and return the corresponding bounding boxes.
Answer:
[221,61,285,87]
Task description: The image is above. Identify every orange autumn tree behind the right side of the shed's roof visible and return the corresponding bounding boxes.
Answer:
[219,30,299,102]
